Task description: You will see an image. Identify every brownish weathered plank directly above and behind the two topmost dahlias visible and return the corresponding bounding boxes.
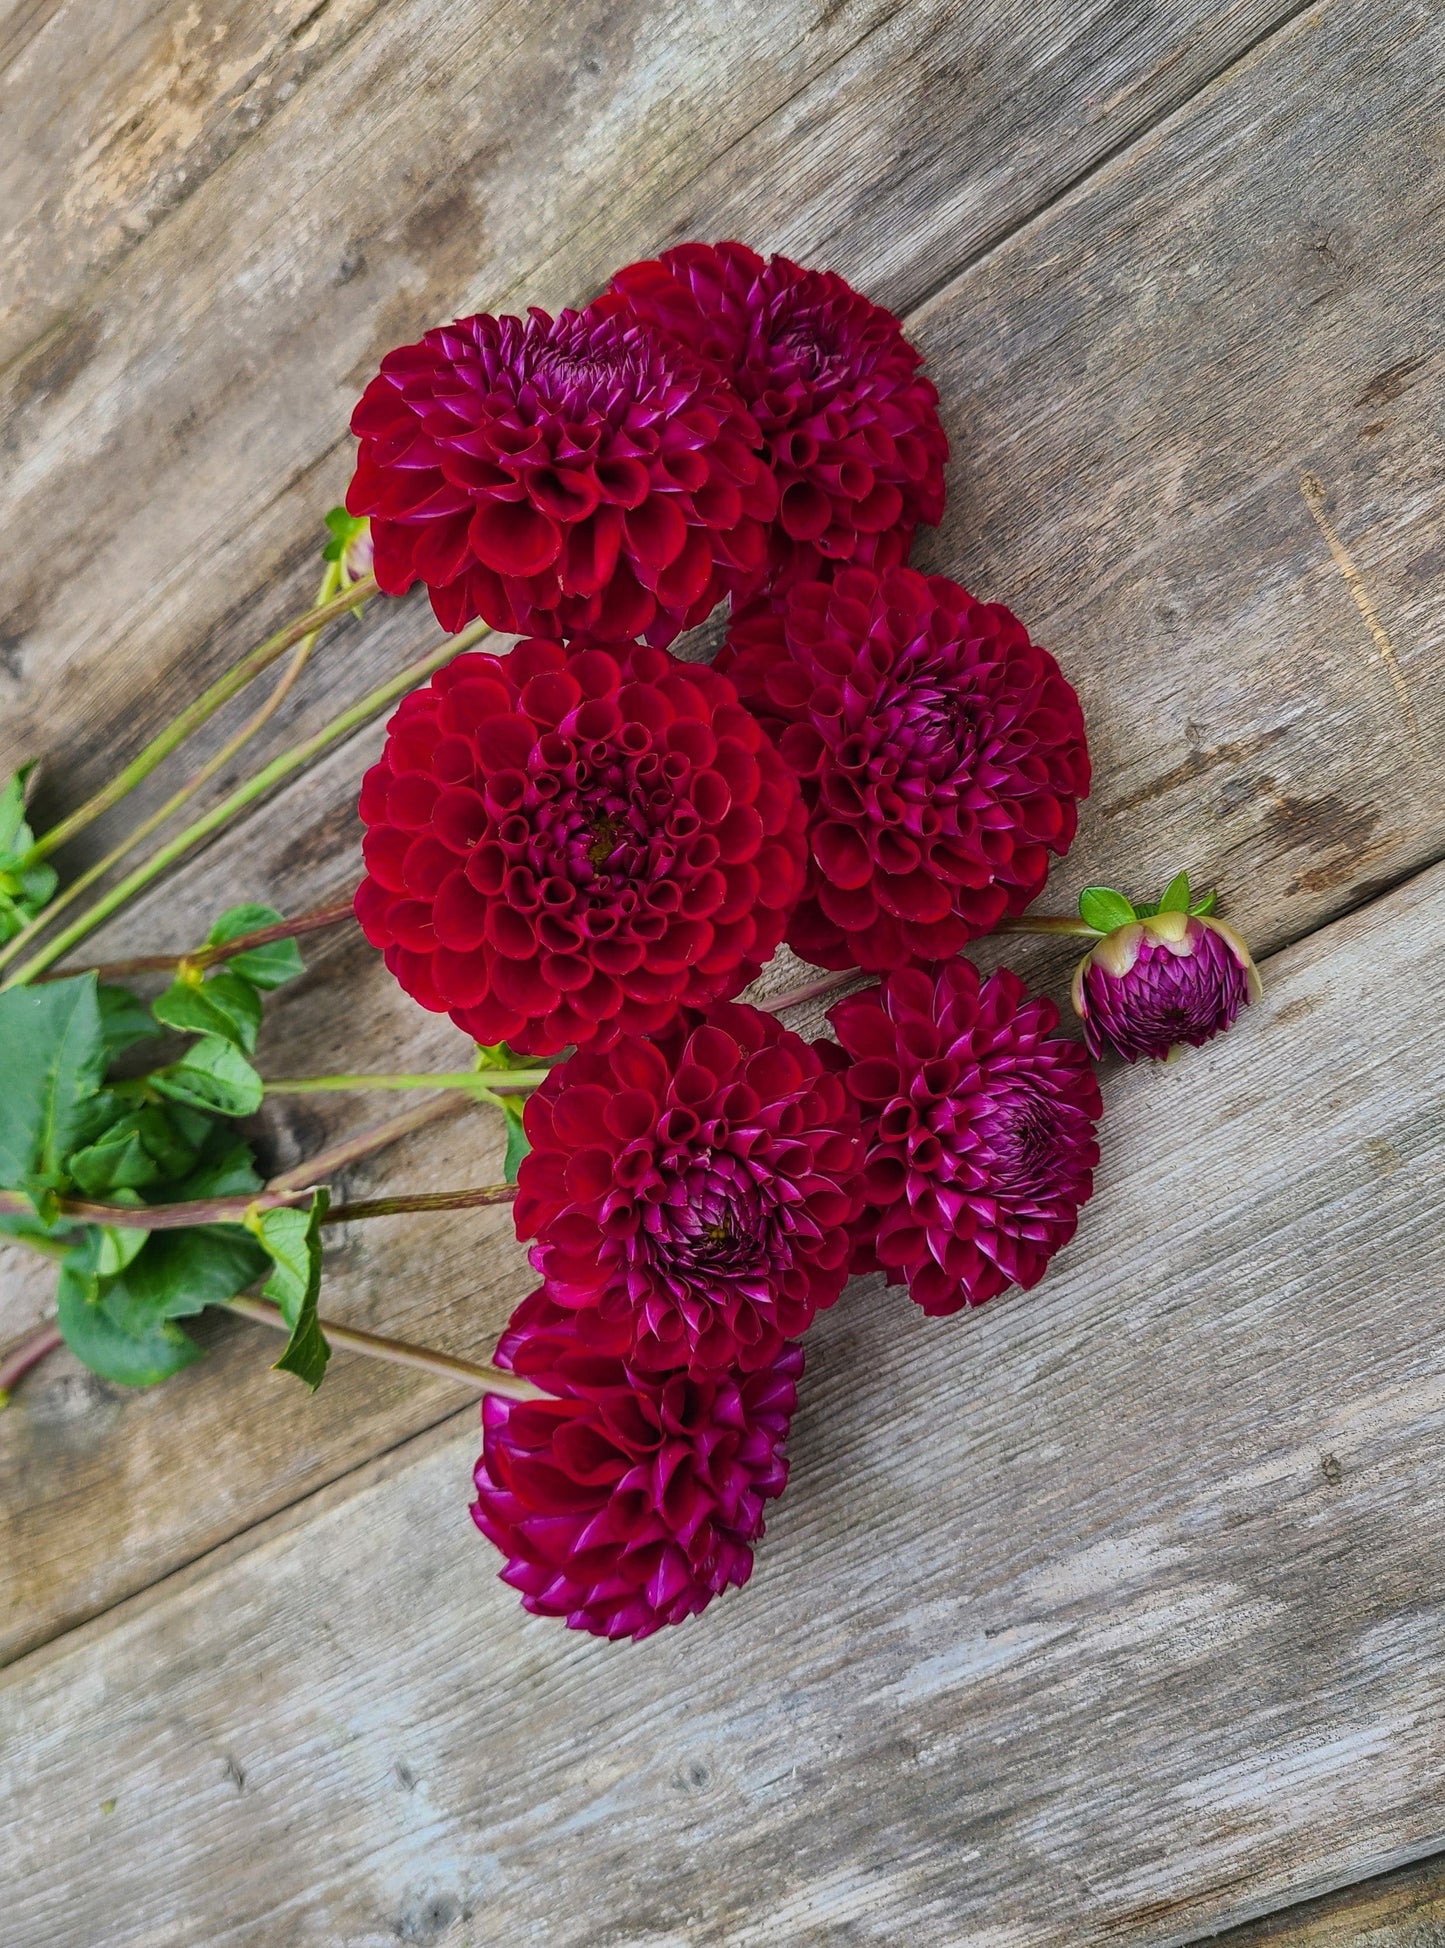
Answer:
[0,0,1316,861]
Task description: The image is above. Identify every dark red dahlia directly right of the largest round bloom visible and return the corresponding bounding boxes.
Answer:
[715,569,1089,970]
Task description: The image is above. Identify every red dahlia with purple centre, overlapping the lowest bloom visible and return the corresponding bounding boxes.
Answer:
[514,1003,861,1373]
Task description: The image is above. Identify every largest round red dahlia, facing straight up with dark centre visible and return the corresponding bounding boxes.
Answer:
[356,637,804,1056]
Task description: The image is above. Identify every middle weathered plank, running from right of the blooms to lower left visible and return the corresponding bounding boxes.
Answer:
[11,8,1439,1675]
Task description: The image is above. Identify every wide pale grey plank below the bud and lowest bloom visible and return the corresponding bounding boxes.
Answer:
[0,845,1445,1948]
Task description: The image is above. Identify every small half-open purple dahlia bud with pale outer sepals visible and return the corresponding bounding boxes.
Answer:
[1073,912,1260,1062]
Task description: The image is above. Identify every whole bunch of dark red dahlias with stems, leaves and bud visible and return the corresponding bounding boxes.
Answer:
[0,244,1256,1638]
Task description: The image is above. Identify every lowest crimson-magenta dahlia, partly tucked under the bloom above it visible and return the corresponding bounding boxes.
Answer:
[471,1293,802,1638]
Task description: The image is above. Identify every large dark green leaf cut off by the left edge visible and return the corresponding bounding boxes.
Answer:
[0,974,109,1190]
